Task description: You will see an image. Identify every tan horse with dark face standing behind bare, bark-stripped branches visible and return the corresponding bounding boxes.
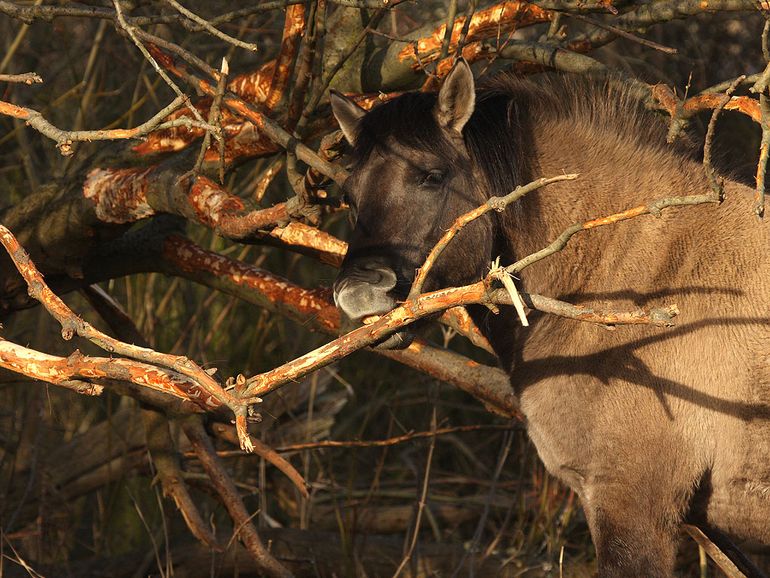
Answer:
[330,59,770,578]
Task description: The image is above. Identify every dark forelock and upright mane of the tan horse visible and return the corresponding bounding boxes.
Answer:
[353,73,676,196]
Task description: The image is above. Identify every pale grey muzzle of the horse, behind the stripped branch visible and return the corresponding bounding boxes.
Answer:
[334,261,414,349]
